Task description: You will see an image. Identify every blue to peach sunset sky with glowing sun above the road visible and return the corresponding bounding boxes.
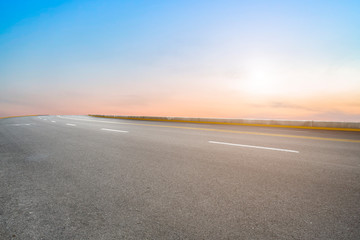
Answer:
[0,0,360,122]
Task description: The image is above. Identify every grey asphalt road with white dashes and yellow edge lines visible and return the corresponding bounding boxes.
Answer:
[0,116,360,239]
